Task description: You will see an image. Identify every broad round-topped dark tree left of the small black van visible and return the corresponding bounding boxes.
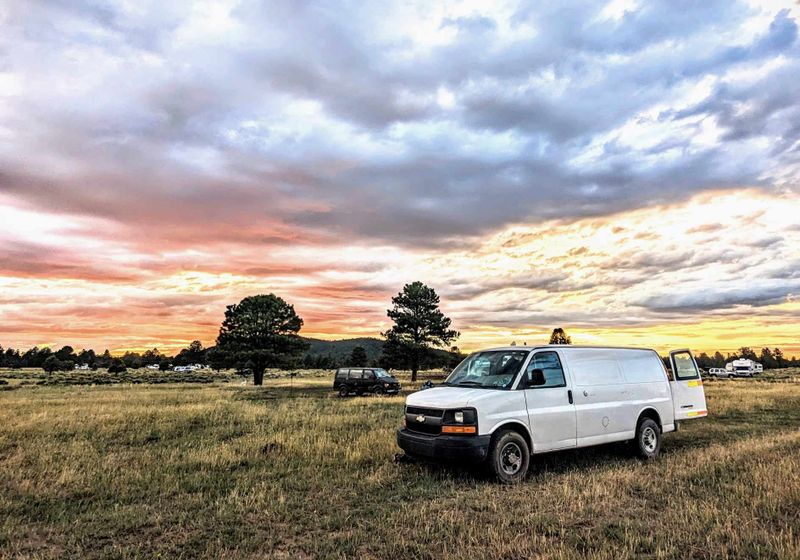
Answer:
[217,294,307,385]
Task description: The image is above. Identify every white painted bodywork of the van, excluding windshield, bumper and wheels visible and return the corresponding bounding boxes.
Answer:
[406,345,705,453]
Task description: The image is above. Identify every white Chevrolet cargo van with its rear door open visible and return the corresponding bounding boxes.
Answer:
[397,345,707,483]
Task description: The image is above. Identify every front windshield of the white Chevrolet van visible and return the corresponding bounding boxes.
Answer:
[445,350,529,389]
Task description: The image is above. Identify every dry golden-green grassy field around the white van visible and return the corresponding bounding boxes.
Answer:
[0,371,800,560]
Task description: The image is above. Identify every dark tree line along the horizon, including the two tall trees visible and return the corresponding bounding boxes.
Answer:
[0,282,800,385]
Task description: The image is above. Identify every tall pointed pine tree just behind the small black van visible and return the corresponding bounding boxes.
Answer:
[383,282,459,381]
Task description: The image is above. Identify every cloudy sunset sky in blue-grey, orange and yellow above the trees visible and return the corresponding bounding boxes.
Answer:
[0,0,800,354]
